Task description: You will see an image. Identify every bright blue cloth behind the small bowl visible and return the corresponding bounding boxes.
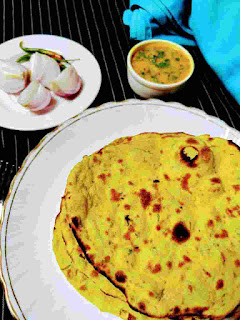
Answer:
[123,0,240,103]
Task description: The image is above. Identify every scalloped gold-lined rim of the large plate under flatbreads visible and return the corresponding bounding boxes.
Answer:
[0,99,240,319]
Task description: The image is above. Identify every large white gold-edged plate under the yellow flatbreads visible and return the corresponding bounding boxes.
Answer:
[1,99,240,320]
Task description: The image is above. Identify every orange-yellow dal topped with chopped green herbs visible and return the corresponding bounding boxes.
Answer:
[131,43,191,84]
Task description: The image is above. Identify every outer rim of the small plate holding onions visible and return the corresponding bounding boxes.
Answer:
[0,33,102,132]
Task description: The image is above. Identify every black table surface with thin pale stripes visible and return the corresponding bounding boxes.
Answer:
[0,0,240,319]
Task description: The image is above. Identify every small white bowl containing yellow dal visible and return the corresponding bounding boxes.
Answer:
[127,39,194,98]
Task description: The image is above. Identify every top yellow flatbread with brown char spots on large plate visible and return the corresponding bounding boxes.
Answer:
[53,133,240,319]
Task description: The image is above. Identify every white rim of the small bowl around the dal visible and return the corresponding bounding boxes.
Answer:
[127,39,195,89]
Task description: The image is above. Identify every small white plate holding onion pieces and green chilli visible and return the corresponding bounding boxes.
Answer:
[0,34,102,130]
